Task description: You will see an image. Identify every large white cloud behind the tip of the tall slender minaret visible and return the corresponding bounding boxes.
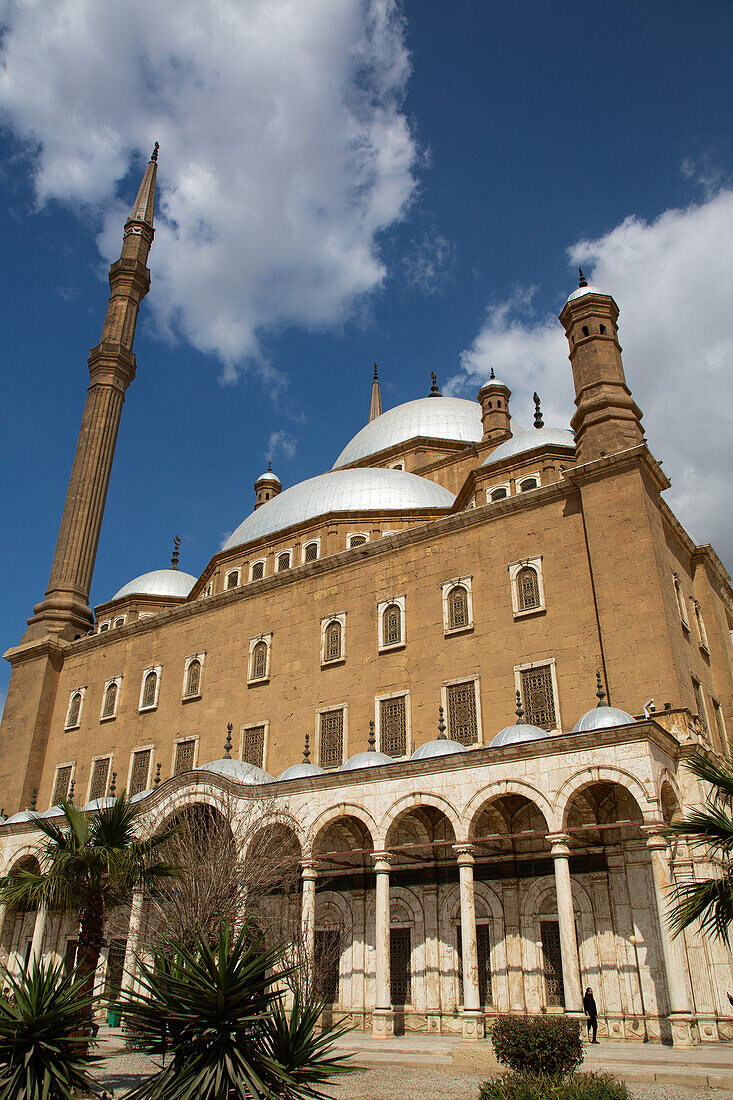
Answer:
[0,0,417,378]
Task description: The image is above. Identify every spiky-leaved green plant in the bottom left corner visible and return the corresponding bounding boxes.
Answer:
[0,960,100,1100]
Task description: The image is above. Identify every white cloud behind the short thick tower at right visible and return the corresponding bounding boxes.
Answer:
[446,189,733,567]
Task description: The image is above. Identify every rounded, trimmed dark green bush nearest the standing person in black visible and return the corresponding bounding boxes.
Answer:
[490,1015,583,1077]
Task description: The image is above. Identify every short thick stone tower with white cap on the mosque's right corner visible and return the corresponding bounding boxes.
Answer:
[560,271,644,463]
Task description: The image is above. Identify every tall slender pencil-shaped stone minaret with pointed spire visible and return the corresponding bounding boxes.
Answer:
[23,142,158,641]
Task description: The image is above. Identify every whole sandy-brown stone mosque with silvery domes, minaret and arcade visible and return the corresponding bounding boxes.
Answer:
[0,149,733,1045]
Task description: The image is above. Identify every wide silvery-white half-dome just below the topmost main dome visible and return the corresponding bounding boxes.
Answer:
[221,466,453,550]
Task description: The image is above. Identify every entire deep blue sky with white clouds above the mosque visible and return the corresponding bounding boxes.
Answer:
[0,0,733,704]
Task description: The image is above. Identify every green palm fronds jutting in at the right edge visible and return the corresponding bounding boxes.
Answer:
[665,754,733,944]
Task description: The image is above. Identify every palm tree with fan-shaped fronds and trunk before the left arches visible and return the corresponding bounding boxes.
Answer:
[0,791,177,982]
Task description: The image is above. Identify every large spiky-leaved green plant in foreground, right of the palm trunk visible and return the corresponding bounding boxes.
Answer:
[119,924,352,1100]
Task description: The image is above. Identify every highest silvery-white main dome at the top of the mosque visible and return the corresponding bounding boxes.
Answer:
[333,397,483,470]
